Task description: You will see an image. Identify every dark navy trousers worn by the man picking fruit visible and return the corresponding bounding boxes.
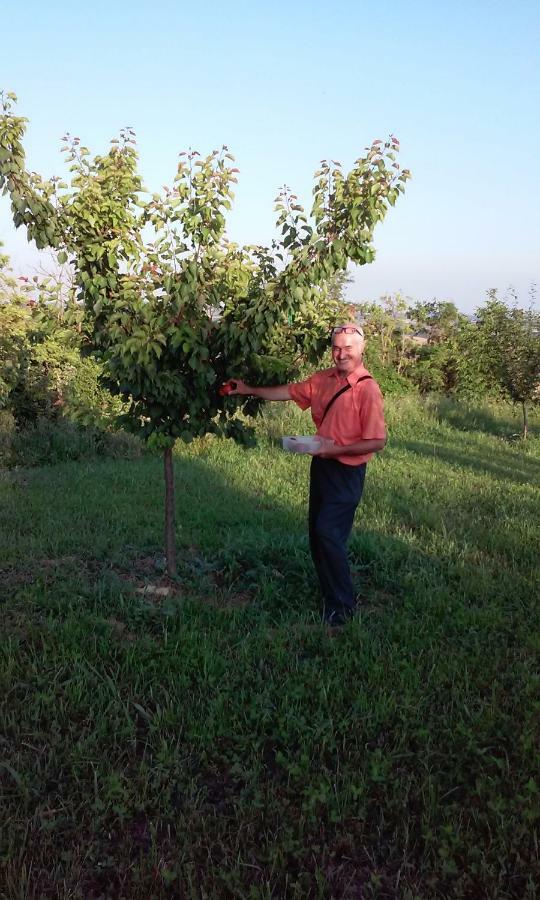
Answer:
[309,456,366,610]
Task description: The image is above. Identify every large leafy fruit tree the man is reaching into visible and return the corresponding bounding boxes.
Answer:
[0,93,409,575]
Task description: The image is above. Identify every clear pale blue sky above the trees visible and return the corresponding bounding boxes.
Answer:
[0,0,540,313]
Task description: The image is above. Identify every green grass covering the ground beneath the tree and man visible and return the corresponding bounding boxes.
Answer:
[0,398,540,900]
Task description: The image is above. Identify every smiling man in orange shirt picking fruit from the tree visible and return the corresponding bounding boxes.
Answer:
[231,322,386,627]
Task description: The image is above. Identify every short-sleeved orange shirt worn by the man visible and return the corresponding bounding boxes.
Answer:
[289,365,386,466]
